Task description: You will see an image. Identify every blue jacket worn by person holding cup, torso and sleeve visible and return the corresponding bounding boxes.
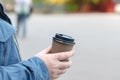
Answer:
[0,2,49,80]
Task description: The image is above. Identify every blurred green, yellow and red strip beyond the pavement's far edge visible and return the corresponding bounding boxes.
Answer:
[0,0,120,13]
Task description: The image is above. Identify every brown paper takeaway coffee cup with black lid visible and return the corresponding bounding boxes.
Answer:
[51,33,75,53]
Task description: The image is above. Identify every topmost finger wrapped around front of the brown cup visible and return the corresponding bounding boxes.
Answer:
[54,51,75,60]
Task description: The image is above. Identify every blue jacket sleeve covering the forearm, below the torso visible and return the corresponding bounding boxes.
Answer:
[0,57,50,80]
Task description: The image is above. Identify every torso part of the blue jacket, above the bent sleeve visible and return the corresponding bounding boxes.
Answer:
[0,18,20,66]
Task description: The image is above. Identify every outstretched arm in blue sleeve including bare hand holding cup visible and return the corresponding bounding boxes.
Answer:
[0,48,74,80]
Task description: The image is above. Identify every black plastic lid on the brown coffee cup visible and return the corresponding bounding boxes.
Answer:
[53,33,75,45]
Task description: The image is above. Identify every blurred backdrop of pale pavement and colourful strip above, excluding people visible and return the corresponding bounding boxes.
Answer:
[1,0,120,80]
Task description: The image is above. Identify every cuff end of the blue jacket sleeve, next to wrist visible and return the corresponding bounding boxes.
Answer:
[23,57,50,80]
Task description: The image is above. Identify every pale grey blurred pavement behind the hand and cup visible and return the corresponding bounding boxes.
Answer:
[10,14,120,80]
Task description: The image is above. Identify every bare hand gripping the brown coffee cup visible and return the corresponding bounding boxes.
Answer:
[36,48,74,80]
